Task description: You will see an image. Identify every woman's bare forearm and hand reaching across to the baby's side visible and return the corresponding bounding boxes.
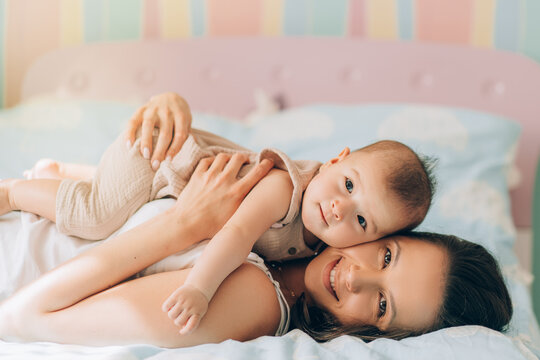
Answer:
[0,156,271,340]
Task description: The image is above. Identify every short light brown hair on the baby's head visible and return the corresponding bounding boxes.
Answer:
[355,140,436,230]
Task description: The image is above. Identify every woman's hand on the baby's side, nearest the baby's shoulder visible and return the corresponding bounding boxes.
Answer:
[171,153,273,240]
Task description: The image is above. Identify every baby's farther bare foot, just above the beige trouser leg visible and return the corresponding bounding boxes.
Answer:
[24,159,96,180]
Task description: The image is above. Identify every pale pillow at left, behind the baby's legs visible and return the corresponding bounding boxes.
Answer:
[0,97,136,179]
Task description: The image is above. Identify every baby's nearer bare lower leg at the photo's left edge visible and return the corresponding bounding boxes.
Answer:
[0,179,60,221]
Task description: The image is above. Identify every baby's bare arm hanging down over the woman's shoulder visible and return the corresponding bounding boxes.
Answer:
[162,169,293,334]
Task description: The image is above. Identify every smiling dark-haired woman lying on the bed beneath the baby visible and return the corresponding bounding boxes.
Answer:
[0,153,512,347]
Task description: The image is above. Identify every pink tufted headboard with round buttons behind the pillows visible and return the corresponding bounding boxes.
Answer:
[22,37,540,226]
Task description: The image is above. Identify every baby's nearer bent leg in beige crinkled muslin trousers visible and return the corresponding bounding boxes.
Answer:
[56,135,155,240]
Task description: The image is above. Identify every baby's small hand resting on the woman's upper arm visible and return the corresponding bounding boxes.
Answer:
[162,284,208,335]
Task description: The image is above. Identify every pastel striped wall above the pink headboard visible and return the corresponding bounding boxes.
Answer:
[0,0,540,107]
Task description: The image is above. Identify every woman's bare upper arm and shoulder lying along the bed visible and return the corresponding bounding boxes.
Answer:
[0,240,280,347]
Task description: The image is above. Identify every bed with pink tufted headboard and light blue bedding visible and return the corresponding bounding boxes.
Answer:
[0,37,540,359]
